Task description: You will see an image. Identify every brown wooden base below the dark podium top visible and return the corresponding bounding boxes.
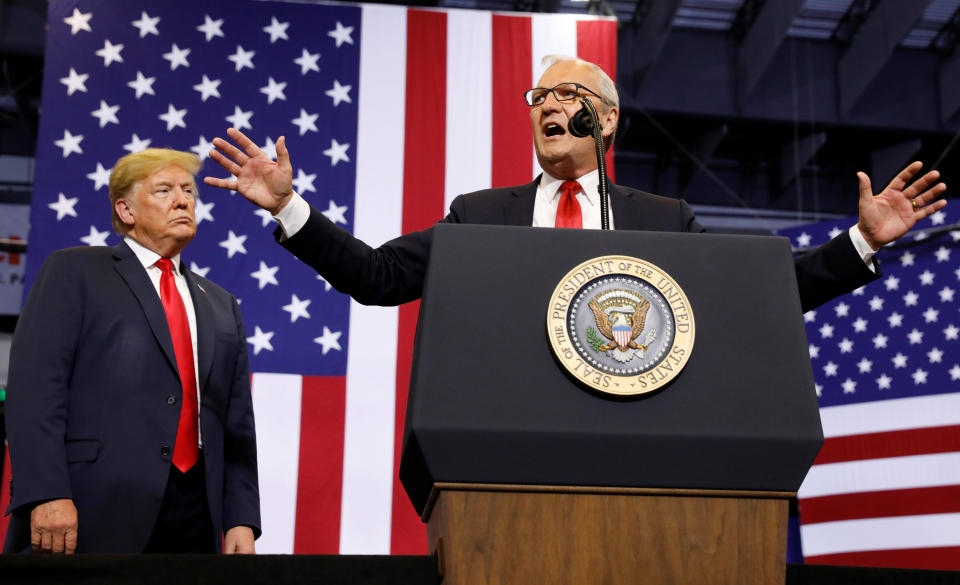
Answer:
[424,483,794,585]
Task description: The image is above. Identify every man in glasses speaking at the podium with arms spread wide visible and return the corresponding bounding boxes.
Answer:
[204,59,946,311]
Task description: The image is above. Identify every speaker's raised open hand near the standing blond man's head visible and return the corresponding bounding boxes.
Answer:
[203,128,293,215]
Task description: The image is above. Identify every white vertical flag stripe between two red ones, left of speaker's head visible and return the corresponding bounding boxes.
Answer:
[443,10,492,211]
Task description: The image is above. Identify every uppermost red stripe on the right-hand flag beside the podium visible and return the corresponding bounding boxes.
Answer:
[814,425,960,465]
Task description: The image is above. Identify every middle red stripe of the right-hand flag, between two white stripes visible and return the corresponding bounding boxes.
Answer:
[800,485,960,525]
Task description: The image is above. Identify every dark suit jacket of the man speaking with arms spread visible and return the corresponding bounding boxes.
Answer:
[274,177,880,311]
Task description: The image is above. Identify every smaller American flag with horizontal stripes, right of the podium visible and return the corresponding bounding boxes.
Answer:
[782,212,960,570]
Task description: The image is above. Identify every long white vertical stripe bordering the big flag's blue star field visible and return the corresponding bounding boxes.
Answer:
[340,4,407,554]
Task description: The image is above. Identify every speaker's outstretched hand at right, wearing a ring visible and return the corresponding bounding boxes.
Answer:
[857,161,947,250]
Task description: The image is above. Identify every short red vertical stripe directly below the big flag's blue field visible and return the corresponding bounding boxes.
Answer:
[293,376,347,554]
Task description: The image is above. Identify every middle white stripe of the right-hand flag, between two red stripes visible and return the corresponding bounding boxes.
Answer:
[797,453,960,498]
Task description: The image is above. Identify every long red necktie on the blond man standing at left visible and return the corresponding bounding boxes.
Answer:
[157,258,200,473]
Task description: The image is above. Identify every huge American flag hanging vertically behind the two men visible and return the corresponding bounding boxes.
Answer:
[0,0,616,554]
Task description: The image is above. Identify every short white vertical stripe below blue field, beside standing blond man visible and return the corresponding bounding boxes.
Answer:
[253,374,303,554]
